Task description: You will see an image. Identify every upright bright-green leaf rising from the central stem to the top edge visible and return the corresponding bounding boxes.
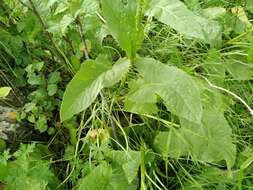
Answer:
[101,0,144,58]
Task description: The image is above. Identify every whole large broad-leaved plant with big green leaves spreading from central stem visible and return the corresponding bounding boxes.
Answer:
[60,0,236,188]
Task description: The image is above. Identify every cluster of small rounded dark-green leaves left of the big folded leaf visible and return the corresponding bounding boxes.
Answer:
[19,62,61,133]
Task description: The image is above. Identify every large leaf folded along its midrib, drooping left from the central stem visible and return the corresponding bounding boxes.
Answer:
[61,56,130,121]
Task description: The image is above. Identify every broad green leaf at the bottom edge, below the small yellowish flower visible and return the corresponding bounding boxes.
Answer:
[77,151,141,190]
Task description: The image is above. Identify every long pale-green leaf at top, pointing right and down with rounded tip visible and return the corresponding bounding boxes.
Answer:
[146,0,221,43]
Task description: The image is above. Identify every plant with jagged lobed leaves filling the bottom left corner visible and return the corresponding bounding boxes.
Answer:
[0,144,57,190]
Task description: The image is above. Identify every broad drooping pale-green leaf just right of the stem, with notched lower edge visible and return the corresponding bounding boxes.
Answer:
[125,58,202,123]
